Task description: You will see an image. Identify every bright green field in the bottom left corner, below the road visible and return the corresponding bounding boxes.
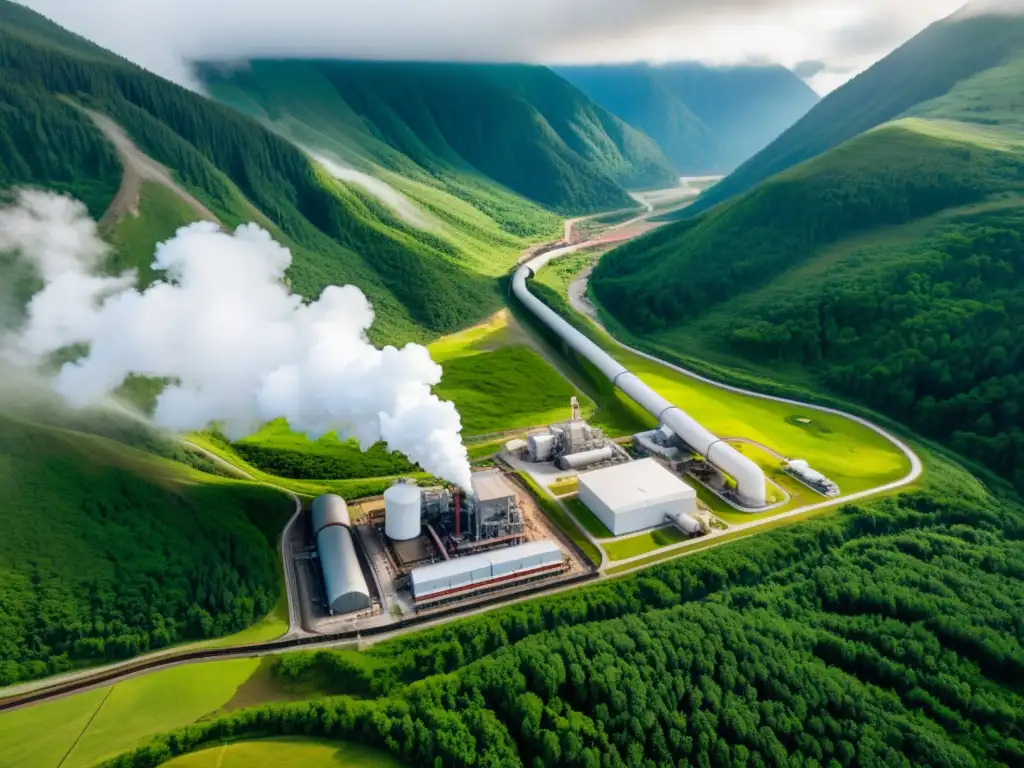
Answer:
[0,658,260,768]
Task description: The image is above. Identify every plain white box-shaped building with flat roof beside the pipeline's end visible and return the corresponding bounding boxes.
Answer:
[579,459,697,536]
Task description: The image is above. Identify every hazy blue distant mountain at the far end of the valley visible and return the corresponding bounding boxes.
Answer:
[555,62,818,175]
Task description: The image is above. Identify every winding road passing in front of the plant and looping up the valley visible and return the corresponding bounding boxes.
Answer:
[0,180,923,712]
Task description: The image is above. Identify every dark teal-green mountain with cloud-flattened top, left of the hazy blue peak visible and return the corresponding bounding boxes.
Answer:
[198,60,674,214]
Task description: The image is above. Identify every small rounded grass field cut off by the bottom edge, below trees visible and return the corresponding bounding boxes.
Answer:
[165,738,401,768]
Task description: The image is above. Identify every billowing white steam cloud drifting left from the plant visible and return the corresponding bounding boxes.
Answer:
[0,190,470,486]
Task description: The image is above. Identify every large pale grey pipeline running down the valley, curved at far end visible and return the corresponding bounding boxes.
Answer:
[512,246,767,507]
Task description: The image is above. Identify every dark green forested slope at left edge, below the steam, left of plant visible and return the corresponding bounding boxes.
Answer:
[0,415,292,686]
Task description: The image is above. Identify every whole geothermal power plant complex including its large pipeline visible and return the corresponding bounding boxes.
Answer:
[298,247,840,631]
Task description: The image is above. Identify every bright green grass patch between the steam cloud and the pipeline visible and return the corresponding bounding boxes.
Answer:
[428,311,595,436]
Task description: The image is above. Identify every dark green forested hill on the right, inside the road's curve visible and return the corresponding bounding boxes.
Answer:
[593,118,1024,487]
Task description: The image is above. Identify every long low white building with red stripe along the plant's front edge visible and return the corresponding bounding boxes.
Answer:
[411,539,565,605]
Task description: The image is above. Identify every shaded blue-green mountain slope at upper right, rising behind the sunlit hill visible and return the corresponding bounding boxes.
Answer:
[687,7,1024,215]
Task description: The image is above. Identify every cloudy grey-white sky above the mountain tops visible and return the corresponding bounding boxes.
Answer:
[20,0,983,94]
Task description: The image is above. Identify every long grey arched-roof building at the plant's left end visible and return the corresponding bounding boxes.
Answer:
[311,494,370,613]
